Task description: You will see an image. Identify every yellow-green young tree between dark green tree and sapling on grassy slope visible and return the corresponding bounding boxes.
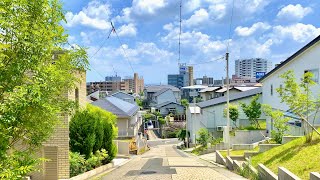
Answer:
[263,105,290,144]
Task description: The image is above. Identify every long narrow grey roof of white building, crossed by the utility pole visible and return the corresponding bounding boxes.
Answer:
[197,88,262,108]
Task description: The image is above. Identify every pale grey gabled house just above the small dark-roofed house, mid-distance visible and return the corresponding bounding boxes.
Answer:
[150,88,177,107]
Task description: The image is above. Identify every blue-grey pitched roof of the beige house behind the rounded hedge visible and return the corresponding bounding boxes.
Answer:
[91,96,139,117]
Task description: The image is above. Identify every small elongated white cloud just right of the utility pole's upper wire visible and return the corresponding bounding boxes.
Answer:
[235,22,271,36]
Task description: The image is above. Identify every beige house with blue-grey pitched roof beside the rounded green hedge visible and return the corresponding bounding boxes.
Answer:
[92,96,142,138]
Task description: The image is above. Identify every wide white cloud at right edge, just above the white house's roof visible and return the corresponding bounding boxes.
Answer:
[272,23,320,43]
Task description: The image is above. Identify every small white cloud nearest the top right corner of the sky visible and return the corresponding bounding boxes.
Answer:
[277,4,312,22]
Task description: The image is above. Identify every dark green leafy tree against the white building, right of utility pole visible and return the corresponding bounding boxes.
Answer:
[241,95,261,128]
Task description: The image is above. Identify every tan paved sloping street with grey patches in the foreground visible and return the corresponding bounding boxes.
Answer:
[102,145,243,180]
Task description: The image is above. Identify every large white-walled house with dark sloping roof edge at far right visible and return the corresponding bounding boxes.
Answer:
[259,36,320,134]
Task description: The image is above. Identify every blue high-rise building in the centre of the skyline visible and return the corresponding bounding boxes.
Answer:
[168,63,193,88]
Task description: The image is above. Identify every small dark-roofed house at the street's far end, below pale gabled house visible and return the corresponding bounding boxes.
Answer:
[155,101,185,116]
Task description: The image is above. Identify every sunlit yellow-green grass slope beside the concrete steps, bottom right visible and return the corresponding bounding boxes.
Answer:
[252,134,320,179]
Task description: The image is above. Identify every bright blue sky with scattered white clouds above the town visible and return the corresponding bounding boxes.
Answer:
[62,0,320,84]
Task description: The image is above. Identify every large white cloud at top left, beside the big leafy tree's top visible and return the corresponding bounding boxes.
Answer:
[65,1,111,30]
